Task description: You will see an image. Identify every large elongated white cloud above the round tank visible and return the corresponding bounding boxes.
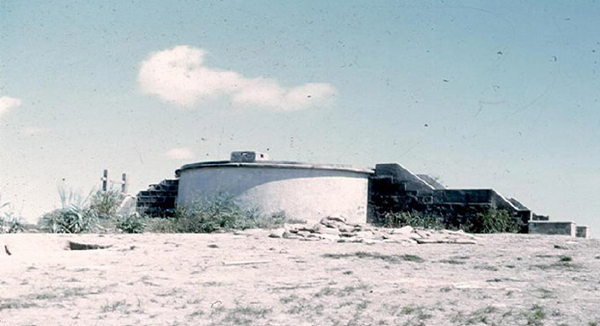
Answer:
[138,45,336,110]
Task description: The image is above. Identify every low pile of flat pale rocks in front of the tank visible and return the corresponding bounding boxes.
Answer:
[269,217,477,244]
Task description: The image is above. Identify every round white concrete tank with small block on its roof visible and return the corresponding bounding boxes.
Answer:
[176,152,373,223]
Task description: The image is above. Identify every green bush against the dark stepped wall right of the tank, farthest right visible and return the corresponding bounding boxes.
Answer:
[464,209,521,233]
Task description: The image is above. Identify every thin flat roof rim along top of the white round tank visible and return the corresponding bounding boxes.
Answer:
[175,161,374,177]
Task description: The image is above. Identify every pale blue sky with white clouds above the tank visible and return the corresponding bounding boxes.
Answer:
[0,0,600,232]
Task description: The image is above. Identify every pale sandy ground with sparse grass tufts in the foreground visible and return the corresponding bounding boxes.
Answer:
[0,230,600,325]
